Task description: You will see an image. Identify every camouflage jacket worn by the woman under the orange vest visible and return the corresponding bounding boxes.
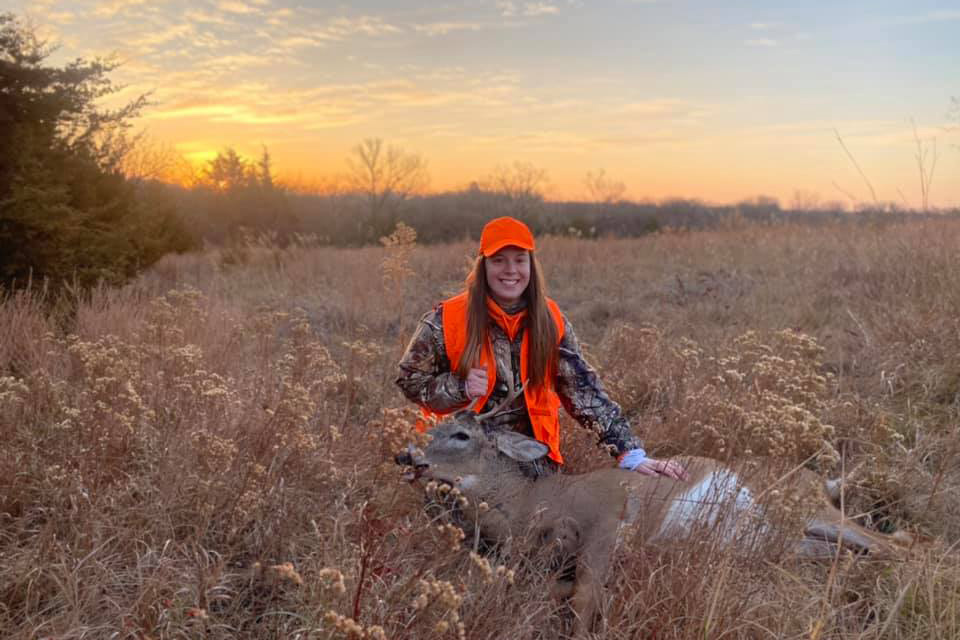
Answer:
[397,306,642,455]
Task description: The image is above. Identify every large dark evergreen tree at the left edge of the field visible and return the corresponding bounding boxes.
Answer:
[0,14,194,288]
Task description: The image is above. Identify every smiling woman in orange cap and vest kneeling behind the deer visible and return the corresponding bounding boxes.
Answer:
[397,217,686,478]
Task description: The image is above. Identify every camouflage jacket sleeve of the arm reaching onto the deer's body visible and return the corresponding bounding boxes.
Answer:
[555,316,643,455]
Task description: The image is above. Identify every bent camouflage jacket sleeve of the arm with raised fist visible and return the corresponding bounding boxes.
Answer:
[396,307,469,411]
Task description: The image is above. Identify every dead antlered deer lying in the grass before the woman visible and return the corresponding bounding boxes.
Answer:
[395,384,911,637]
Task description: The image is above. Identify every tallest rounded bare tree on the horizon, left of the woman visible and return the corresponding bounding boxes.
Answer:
[347,138,430,238]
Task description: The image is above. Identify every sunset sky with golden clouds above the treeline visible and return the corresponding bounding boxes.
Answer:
[9,0,960,207]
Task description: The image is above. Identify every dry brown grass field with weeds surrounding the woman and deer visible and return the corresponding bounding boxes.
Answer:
[0,221,960,640]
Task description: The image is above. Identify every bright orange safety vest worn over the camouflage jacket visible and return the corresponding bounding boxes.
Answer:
[422,292,563,464]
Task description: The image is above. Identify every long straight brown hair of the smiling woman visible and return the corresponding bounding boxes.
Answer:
[456,251,557,387]
